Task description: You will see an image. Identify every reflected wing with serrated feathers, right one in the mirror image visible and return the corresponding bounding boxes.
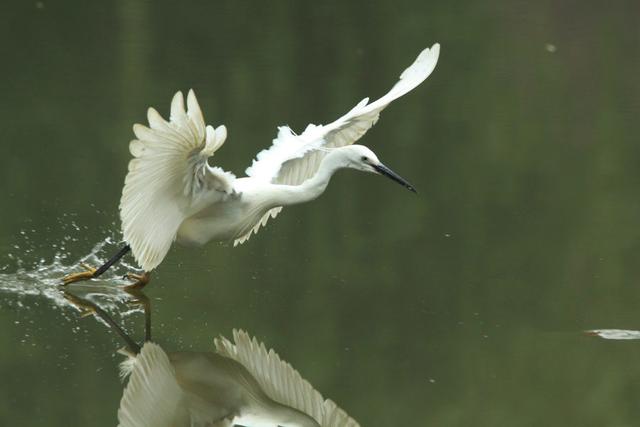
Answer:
[215,330,359,427]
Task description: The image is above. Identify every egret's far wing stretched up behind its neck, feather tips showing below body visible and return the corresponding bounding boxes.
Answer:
[235,43,440,244]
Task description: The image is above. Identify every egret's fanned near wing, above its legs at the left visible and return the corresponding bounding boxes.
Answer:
[120,90,235,271]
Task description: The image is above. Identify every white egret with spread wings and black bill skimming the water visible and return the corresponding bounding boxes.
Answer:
[64,43,440,285]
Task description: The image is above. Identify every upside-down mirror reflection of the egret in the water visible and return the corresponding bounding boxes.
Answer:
[63,288,358,427]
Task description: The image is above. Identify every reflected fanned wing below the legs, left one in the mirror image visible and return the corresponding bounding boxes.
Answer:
[118,342,189,427]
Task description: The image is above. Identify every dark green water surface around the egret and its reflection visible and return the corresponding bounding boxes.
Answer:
[0,0,640,427]
